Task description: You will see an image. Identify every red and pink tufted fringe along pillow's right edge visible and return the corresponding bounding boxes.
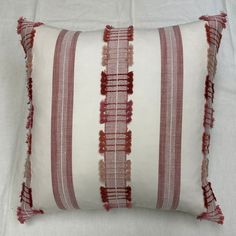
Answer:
[197,13,226,224]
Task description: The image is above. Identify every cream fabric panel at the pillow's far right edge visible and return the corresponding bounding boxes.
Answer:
[178,22,207,215]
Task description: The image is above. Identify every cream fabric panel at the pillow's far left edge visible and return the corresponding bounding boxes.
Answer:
[31,26,60,212]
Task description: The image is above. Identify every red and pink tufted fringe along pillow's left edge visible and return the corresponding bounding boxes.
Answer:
[17,17,43,224]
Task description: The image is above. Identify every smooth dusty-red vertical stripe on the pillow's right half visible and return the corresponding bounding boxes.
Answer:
[157,26,183,209]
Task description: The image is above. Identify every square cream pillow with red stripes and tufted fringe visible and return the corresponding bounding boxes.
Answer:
[17,13,226,224]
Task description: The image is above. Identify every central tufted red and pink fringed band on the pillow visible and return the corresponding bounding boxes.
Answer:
[99,26,133,210]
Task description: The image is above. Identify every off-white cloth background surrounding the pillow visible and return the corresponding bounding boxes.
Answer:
[0,0,236,236]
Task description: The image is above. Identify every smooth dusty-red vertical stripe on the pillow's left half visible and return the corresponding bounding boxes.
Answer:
[51,30,79,209]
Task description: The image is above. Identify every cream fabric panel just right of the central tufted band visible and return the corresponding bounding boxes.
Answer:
[129,30,161,208]
